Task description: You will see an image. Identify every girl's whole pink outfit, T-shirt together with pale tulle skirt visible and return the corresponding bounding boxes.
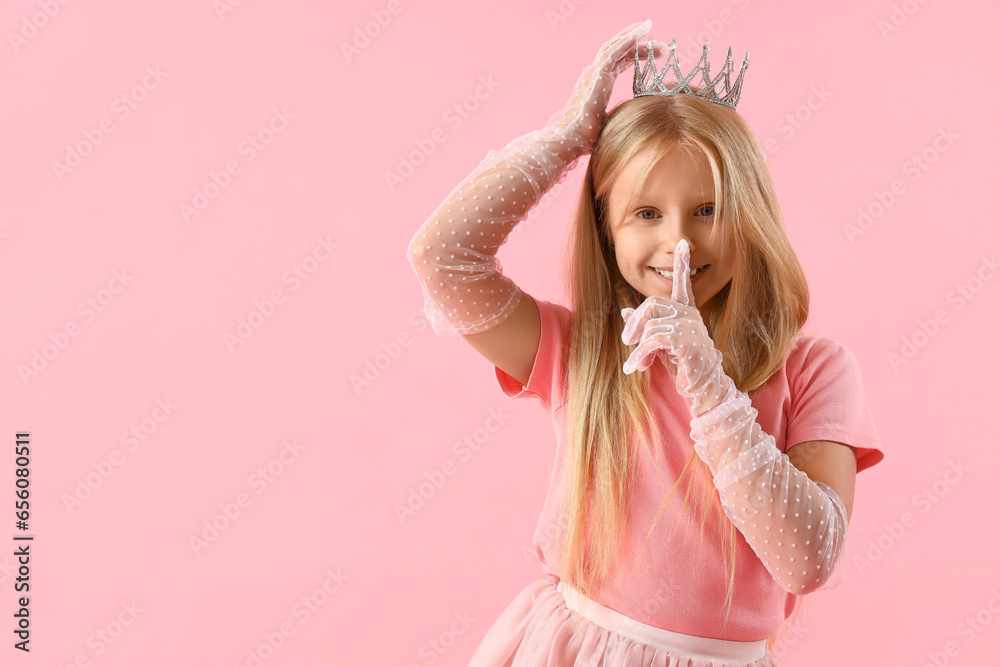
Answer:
[470,294,884,667]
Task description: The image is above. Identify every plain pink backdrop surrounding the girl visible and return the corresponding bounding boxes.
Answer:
[0,0,1000,667]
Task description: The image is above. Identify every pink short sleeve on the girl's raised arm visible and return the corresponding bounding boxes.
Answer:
[493,293,571,412]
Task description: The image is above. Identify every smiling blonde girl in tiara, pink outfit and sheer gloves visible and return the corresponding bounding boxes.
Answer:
[408,21,884,667]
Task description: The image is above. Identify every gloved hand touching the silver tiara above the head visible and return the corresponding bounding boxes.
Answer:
[548,19,667,153]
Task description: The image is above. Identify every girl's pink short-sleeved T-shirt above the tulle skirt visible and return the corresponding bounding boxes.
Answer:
[494,294,885,641]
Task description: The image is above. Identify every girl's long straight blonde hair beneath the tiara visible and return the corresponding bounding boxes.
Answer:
[562,89,809,648]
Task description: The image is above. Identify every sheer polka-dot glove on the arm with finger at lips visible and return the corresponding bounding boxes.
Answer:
[622,240,847,595]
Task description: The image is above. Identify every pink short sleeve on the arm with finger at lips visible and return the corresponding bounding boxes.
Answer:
[785,338,885,472]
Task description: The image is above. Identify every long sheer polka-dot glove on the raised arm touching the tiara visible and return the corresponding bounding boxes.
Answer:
[407,21,667,336]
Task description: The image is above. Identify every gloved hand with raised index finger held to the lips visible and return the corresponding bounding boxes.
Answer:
[622,239,728,416]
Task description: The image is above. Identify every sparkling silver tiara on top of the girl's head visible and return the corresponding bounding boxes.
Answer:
[632,37,750,110]
